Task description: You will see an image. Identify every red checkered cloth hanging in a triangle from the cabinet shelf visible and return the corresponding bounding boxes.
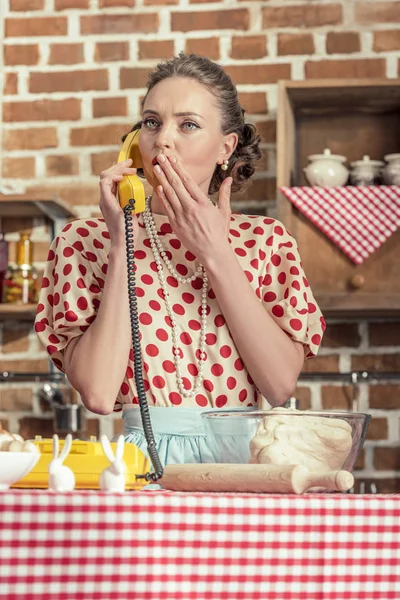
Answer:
[280,185,400,264]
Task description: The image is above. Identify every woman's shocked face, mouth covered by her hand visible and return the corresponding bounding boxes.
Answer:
[139,77,237,194]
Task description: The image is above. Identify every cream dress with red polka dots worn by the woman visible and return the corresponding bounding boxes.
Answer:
[35,215,325,410]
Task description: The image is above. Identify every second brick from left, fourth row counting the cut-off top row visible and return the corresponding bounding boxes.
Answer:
[29,69,108,93]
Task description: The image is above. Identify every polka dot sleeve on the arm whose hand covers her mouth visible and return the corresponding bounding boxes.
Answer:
[261,221,326,358]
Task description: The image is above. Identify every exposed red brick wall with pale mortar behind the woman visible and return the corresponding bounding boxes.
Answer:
[0,0,400,491]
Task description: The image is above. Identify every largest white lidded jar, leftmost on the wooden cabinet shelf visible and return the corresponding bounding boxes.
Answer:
[303,148,349,187]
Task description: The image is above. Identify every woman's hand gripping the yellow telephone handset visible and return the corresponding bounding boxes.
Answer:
[100,158,139,248]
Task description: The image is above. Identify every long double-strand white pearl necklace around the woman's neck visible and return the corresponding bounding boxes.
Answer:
[143,196,208,398]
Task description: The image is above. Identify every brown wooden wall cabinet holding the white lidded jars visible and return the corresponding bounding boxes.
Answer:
[277,80,400,317]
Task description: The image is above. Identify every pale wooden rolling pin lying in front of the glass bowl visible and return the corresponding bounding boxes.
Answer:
[159,463,354,494]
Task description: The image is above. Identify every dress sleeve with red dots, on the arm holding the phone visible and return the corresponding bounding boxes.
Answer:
[35,233,102,372]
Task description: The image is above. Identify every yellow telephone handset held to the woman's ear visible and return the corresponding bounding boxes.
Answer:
[118,129,146,213]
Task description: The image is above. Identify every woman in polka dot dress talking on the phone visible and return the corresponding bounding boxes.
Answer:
[35,53,325,463]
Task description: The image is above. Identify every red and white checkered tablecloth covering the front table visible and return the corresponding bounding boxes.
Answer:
[0,490,400,600]
